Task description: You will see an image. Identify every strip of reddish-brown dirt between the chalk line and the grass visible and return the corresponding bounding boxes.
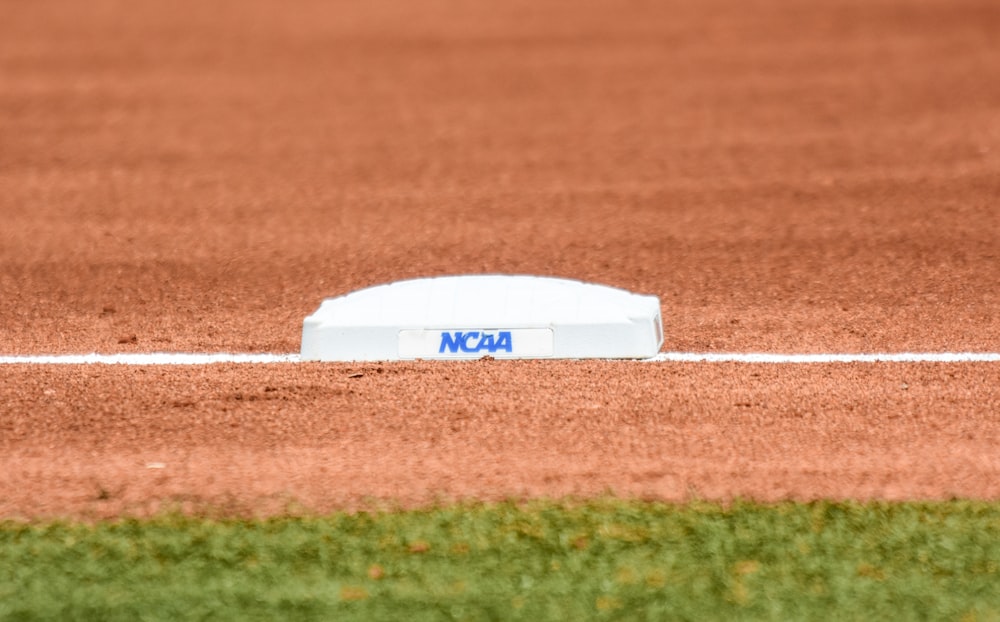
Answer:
[0,361,1000,517]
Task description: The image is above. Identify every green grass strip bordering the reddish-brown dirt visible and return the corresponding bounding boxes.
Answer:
[0,500,1000,620]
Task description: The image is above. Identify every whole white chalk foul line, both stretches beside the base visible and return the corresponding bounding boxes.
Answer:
[0,352,1000,365]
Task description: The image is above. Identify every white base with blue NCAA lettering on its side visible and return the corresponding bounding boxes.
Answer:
[302,275,663,361]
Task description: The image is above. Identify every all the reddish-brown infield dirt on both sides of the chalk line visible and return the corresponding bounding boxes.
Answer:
[0,0,1000,516]
